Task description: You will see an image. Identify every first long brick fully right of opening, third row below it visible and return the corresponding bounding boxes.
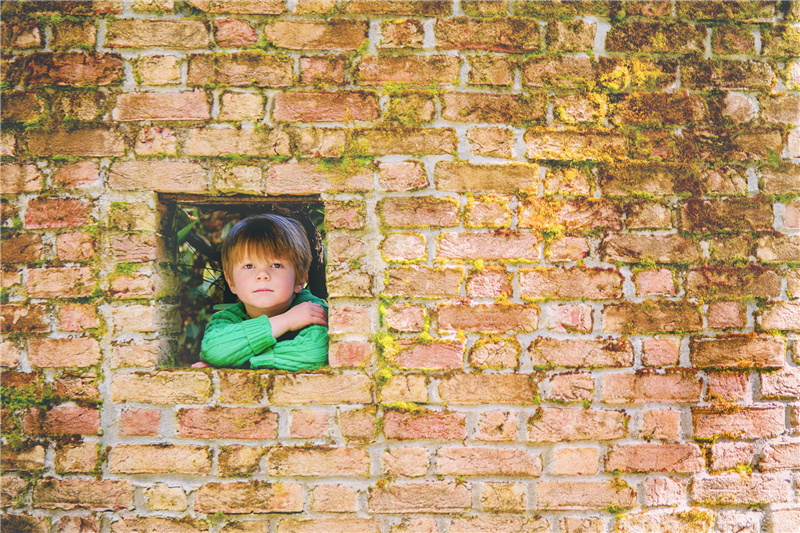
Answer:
[436,447,542,477]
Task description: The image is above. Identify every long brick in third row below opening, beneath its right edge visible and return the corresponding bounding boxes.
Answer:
[267,446,370,477]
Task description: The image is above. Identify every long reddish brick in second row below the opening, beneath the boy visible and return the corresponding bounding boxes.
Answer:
[177,406,278,439]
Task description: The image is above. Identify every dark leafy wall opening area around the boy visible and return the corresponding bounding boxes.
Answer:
[160,195,328,366]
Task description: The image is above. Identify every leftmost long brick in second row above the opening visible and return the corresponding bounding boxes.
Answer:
[28,129,125,157]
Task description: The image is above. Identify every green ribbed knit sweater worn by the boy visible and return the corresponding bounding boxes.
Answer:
[200,290,328,371]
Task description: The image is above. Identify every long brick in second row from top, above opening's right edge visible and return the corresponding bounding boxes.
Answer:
[264,19,369,50]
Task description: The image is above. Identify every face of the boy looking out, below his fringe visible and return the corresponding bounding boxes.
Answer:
[225,253,305,318]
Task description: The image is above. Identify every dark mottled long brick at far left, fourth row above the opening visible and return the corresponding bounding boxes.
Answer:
[11,52,124,87]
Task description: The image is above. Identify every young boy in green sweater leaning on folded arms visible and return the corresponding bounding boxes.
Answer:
[195,215,328,371]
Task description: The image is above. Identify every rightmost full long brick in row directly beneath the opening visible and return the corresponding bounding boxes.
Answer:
[603,371,703,404]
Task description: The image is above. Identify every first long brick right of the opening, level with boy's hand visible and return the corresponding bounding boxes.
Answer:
[438,304,539,333]
